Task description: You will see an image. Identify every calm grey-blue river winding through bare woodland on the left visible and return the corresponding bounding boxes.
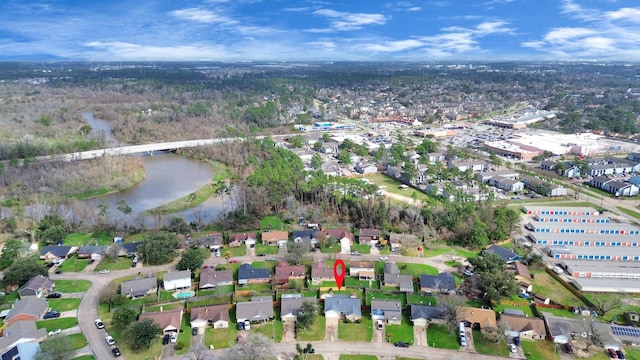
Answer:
[83,113,228,224]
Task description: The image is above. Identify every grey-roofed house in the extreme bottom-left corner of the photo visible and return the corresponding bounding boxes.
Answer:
[0,321,47,354]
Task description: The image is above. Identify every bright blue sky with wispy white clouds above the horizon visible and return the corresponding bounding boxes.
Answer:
[0,0,640,62]
